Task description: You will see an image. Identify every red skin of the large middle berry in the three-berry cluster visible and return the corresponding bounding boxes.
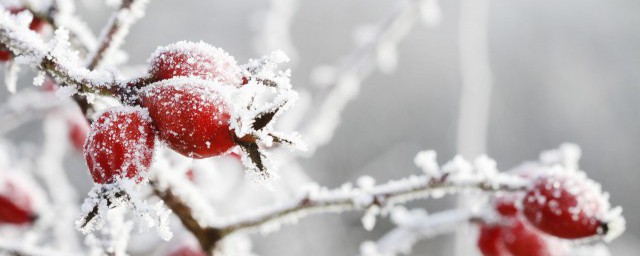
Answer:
[142,84,236,158]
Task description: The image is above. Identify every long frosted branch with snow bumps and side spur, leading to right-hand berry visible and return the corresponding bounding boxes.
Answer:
[210,152,529,234]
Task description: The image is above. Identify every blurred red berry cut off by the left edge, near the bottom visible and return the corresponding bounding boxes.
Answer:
[0,181,35,225]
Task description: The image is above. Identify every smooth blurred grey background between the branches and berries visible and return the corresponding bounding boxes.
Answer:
[5,0,640,256]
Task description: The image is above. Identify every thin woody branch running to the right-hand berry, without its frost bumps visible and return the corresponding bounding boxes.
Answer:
[215,174,529,235]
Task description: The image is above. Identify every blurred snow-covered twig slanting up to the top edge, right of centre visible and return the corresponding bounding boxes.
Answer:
[301,0,438,154]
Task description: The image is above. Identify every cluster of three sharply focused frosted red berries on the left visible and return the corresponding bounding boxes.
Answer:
[84,42,278,184]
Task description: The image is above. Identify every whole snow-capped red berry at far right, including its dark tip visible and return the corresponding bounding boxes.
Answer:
[522,166,624,240]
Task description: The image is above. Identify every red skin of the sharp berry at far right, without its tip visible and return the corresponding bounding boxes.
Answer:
[522,175,601,239]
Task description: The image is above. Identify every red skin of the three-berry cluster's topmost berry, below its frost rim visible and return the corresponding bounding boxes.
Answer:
[149,46,243,84]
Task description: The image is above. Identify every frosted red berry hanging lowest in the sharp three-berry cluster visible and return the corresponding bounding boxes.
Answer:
[84,107,155,184]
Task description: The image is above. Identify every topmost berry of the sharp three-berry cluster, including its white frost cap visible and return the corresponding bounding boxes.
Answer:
[149,41,243,85]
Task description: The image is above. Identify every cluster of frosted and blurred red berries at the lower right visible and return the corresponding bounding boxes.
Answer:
[478,170,611,256]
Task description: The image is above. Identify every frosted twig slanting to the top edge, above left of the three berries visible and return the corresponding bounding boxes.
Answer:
[87,0,150,70]
